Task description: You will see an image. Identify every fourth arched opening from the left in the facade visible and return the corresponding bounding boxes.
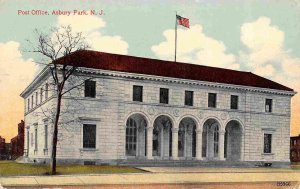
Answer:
[202,119,220,159]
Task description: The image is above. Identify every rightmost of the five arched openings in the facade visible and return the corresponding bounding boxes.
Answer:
[224,120,242,161]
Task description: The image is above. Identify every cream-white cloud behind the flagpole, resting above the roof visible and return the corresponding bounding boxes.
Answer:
[151,25,239,69]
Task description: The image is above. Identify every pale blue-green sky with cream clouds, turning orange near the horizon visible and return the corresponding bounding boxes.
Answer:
[0,0,300,140]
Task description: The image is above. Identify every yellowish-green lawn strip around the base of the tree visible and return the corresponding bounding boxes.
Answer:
[0,161,143,177]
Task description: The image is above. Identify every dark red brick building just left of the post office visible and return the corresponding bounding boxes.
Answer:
[10,120,25,159]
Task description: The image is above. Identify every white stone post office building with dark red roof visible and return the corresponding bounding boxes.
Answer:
[21,51,295,167]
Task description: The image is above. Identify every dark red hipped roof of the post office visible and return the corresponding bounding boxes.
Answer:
[55,50,293,91]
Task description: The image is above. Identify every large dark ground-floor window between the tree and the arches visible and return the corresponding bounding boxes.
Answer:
[83,124,96,148]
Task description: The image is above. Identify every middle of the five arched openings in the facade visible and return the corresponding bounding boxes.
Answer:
[178,117,196,158]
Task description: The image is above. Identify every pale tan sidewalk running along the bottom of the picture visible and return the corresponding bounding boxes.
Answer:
[0,170,300,187]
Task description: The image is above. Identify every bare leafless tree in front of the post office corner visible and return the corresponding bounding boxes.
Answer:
[28,26,89,175]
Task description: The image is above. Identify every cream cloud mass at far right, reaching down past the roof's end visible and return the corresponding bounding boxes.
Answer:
[238,17,300,134]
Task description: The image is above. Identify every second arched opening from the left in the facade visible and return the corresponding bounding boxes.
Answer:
[152,115,172,158]
